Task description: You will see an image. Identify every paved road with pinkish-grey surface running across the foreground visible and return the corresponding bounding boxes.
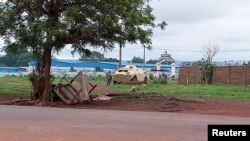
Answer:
[0,106,250,141]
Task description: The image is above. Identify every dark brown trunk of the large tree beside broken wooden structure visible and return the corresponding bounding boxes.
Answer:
[42,48,51,104]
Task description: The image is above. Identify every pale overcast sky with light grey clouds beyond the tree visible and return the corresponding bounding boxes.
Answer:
[1,0,250,61]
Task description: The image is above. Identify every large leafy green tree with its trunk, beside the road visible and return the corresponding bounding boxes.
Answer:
[0,0,166,102]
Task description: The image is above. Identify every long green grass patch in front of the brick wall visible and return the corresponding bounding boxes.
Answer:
[141,81,250,100]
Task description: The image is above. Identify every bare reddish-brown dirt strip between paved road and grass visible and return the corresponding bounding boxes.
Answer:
[0,85,250,117]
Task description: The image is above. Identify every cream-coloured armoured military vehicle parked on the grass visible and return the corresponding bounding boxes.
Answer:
[112,65,149,84]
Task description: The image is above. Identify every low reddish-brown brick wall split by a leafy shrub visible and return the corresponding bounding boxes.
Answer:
[178,66,250,85]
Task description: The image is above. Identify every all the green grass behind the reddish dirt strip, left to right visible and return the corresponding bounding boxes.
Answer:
[0,76,250,100]
